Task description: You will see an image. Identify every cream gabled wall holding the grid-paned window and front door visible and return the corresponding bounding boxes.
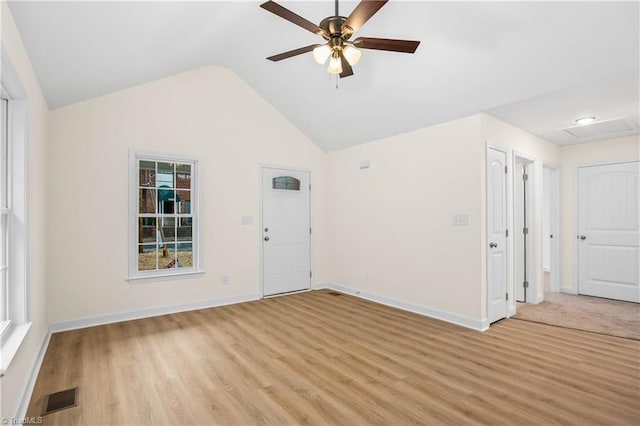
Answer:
[48,66,326,323]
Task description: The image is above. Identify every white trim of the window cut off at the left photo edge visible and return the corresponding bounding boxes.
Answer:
[0,46,31,376]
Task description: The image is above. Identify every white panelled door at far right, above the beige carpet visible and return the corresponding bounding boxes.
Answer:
[577,161,640,302]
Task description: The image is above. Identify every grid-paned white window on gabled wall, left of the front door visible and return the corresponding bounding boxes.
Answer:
[129,152,199,279]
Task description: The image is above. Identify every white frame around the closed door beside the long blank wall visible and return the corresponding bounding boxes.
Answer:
[482,141,515,322]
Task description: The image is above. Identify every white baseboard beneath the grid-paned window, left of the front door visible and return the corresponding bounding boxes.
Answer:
[51,293,262,333]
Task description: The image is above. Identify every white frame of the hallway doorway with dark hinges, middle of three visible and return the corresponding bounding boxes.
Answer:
[510,151,543,303]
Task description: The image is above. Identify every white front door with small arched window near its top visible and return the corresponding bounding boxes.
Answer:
[262,167,311,296]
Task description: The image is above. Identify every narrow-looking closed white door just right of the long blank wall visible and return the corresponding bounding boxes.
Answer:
[486,148,507,323]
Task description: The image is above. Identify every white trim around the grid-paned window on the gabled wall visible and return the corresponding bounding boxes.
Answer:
[127,150,204,283]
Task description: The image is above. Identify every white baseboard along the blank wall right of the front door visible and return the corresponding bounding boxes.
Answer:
[315,282,489,331]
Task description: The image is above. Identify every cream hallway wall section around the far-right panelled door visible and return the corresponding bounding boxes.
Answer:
[560,136,640,293]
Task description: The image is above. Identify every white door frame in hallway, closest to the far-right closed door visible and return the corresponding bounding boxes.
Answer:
[542,163,561,293]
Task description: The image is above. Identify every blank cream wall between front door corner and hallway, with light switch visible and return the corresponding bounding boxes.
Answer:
[327,116,484,321]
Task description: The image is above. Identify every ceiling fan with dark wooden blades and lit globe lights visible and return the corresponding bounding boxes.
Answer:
[260,0,420,78]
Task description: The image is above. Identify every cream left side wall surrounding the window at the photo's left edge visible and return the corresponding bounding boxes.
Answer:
[0,1,49,418]
